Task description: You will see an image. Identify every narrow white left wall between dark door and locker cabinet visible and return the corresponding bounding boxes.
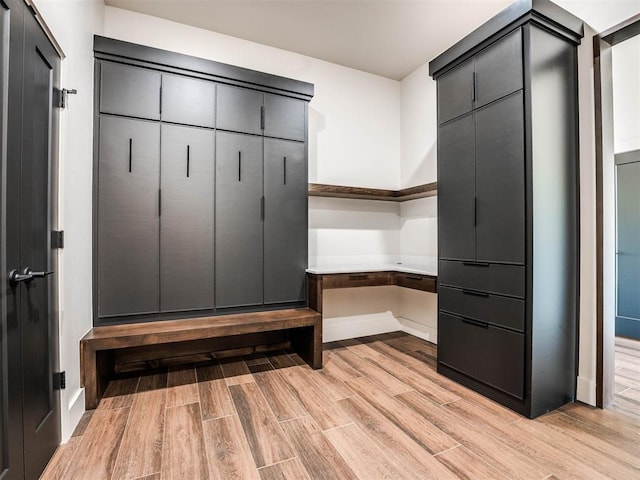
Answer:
[35,0,104,442]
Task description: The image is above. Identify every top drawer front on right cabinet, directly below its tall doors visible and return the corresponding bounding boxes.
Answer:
[438,260,526,298]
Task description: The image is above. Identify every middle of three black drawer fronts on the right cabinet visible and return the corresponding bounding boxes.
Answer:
[438,287,525,332]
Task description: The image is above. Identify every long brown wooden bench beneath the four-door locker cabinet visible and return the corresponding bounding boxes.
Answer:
[80,308,322,410]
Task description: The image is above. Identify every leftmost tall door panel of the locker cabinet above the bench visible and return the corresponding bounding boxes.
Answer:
[98,115,160,317]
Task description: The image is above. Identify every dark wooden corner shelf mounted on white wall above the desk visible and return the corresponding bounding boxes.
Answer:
[309,182,438,202]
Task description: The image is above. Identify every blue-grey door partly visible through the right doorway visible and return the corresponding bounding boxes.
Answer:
[616,151,640,339]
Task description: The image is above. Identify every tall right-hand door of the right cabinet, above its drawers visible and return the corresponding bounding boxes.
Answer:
[476,92,525,264]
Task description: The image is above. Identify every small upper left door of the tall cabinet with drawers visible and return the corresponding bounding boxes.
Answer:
[438,59,474,124]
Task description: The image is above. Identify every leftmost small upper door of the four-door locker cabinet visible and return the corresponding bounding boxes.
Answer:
[100,62,160,120]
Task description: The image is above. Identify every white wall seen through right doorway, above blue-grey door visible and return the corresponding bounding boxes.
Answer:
[611,35,640,153]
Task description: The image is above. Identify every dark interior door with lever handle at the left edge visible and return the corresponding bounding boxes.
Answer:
[0,1,60,479]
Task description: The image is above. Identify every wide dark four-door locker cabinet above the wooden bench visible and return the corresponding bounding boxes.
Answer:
[94,37,313,325]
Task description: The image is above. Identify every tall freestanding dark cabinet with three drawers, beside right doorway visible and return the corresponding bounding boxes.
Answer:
[429,0,583,417]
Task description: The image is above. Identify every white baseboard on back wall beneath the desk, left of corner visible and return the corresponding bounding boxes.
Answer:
[322,312,401,342]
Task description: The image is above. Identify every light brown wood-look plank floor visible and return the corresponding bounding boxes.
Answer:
[42,333,640,480]
